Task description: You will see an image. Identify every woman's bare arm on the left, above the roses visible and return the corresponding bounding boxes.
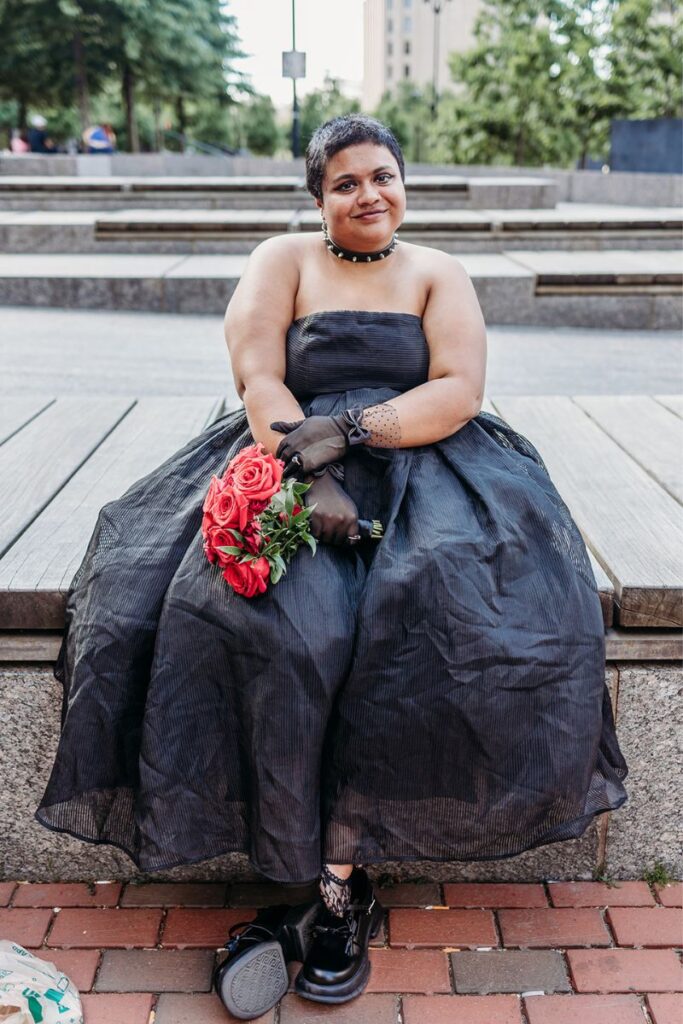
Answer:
[224,236,304,455]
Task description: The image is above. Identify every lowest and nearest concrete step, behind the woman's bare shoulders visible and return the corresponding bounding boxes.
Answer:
[0,250,683,330]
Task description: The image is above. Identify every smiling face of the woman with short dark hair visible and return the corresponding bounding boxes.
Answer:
[315,142,405,252]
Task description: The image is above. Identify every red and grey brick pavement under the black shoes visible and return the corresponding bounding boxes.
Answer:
[0,881,683,1024]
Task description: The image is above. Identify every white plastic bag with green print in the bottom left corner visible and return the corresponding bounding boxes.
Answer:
[0,939,83,1024]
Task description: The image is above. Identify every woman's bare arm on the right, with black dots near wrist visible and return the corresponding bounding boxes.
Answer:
[362,253,486,447]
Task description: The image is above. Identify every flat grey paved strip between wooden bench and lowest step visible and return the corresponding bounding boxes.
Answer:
[0,306,683,402]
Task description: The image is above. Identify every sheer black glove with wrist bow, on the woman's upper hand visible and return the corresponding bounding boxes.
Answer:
[270,406,371,477]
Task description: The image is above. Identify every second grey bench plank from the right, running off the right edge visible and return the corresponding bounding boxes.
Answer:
[573,394,683,502]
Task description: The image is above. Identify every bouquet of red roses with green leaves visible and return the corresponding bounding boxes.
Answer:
[202,441,317,597]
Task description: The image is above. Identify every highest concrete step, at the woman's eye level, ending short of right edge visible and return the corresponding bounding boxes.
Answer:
[0,174,557,210]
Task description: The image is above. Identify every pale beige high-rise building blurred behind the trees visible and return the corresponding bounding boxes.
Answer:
[362,0,482,111]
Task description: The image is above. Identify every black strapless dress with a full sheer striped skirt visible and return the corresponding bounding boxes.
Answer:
[36,310,628,882]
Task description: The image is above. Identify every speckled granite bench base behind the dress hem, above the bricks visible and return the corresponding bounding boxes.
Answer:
[0,662,683,882]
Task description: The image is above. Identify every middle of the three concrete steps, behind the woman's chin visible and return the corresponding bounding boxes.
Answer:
[0,203,683,254]
